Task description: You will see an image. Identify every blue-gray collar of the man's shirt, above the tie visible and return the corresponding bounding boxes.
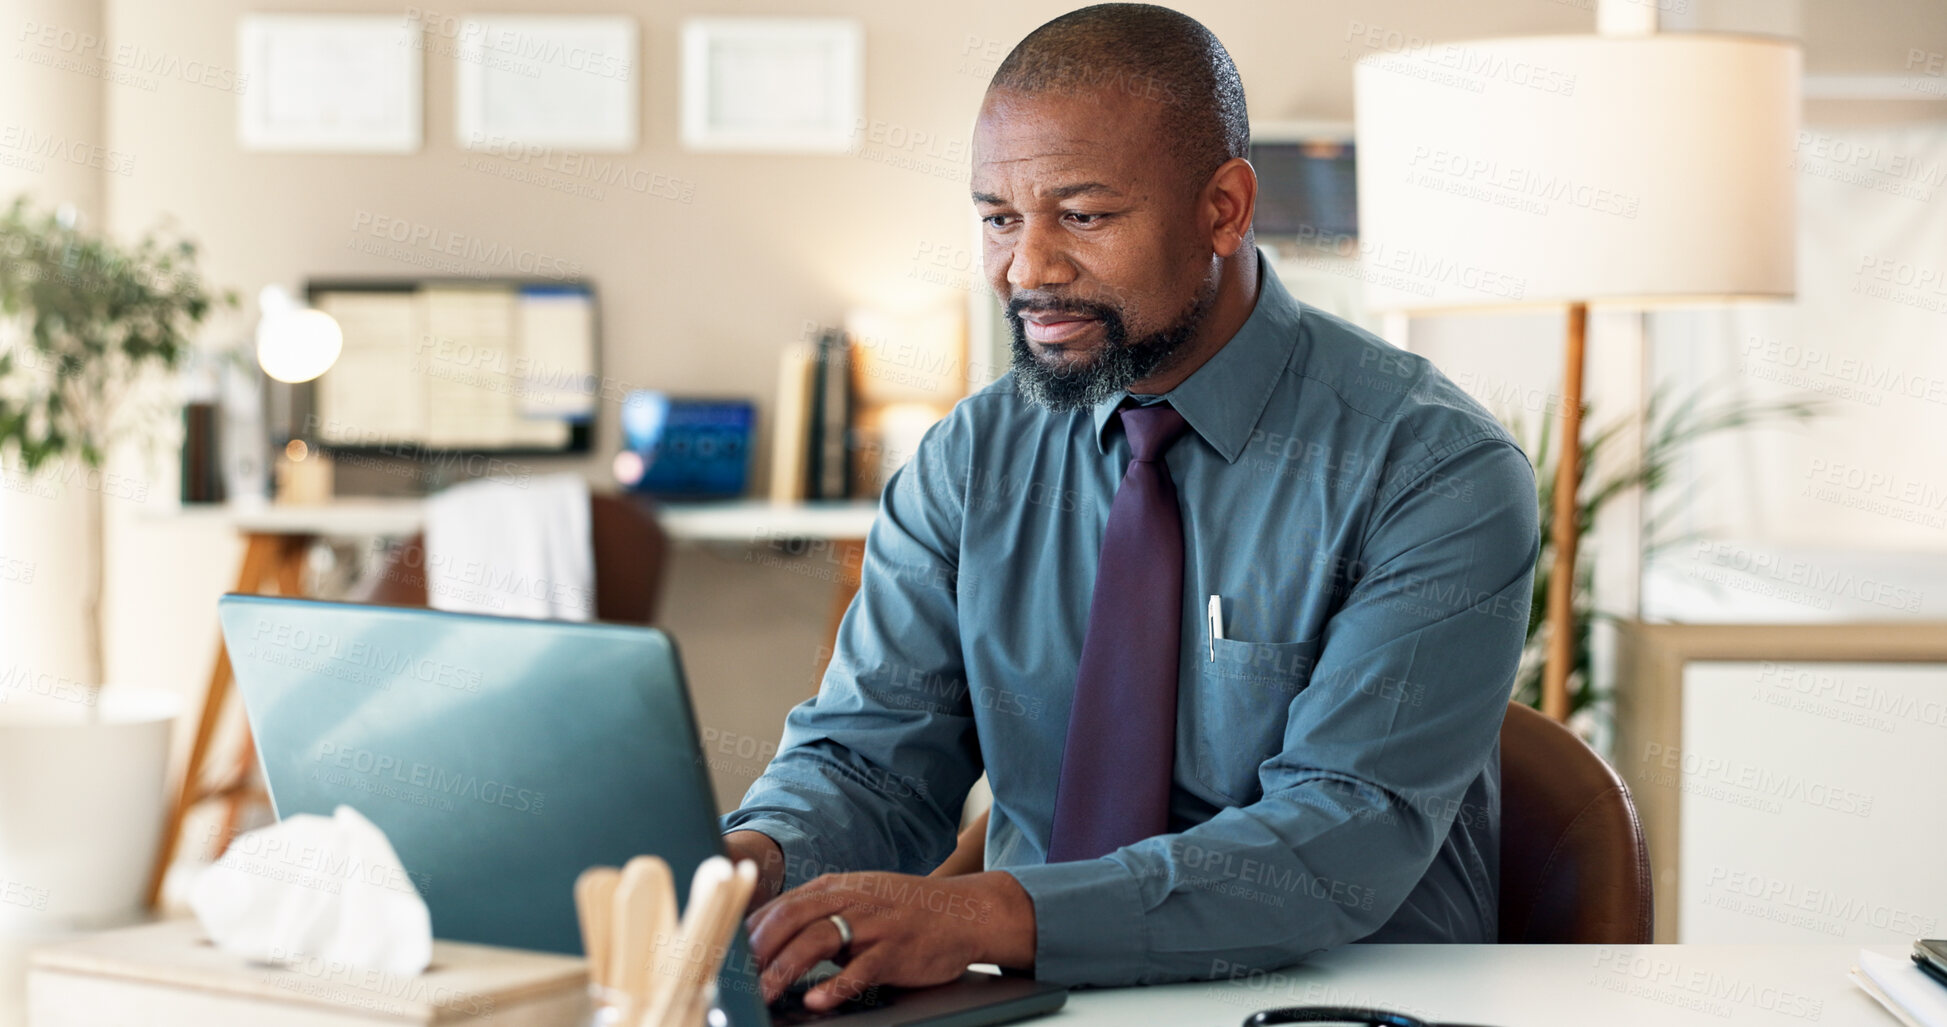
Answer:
[1092,249,1299,464]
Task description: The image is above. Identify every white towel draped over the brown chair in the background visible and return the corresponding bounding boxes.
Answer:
[426,474,596,620]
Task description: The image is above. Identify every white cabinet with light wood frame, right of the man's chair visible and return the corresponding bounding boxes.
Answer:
[1612,622,1947,945]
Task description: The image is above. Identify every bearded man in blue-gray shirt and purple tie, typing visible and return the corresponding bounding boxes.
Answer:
[724,4,1538,1009]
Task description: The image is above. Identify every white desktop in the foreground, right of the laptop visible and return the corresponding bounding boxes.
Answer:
[1034,945,1906,1027]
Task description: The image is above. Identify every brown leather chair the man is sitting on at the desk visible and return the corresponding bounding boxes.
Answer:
[933,704,1651,945]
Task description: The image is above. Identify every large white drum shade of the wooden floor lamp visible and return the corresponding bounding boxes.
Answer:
[1353,35,1801,310]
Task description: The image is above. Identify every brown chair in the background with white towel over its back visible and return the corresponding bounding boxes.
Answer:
[362,493,670,624]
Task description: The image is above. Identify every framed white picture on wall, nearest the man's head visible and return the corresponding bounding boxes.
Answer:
[683,18,864,154]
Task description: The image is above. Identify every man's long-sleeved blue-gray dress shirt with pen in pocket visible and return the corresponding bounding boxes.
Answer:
[722,259,1538,984]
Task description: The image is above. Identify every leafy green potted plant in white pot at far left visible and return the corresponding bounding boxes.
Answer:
[0,199,236,933]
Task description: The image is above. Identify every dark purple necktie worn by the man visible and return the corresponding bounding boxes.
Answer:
[1047,403,1186,863]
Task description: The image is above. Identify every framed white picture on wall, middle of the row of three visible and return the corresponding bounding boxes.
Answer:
[454,14,643,152]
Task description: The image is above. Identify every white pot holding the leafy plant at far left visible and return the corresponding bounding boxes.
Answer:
[0,684,181,935]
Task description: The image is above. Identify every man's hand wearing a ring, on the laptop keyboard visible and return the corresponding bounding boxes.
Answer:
[744,871,1034,1011]
